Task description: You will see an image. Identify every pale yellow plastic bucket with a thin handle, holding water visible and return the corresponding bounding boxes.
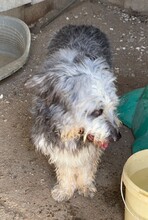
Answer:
[121,150,148,220]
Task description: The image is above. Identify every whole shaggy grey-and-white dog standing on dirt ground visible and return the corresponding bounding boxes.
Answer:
[27,25,120,201]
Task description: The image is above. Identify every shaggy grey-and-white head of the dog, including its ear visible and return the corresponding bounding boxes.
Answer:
[28,51,121,149]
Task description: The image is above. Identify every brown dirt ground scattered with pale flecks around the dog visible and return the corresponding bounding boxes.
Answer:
[0,1,148,220]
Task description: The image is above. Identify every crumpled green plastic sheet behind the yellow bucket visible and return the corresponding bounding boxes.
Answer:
[118,86,148,153]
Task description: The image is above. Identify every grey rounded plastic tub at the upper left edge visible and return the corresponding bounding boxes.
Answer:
[0,16,31,80]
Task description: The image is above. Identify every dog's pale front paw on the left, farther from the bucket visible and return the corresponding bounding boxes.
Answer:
[51,185,74,202]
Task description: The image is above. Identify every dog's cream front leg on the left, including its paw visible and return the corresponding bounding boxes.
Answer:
[51,165,76,202]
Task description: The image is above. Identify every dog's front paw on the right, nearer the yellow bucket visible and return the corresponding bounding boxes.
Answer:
[78,183,97,198]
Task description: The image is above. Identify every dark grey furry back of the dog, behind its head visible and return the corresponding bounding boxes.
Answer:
[48,25,111,66]
